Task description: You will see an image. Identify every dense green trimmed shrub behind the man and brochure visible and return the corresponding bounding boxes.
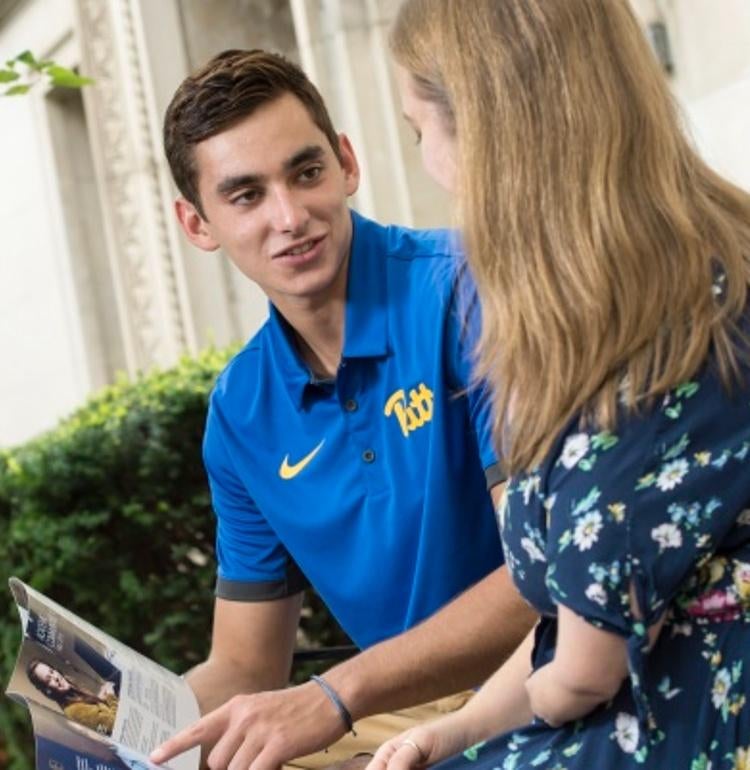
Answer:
[0,350,352,770]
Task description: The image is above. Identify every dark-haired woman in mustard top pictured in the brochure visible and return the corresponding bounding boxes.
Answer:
[26,658,118,735]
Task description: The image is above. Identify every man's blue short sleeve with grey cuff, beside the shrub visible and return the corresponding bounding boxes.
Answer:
[203,396,307,601]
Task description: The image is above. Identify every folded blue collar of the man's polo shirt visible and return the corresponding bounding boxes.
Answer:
[269,211,388,409]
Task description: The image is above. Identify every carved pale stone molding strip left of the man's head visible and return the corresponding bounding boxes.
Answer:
[76,0,192,372]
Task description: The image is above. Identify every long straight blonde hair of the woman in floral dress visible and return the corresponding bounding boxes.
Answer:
[391,0,750,473]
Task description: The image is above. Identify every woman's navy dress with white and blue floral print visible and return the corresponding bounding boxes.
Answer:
[440,360,750,770]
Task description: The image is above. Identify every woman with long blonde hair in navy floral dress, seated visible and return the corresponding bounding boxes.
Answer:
[371,0,750,770]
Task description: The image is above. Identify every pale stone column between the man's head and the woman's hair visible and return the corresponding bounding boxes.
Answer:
[291,0,450,226]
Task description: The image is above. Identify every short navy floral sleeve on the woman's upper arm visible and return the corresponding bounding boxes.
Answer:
[546,374,750,635]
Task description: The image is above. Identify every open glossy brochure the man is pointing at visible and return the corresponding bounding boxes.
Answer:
[7,578,200,770]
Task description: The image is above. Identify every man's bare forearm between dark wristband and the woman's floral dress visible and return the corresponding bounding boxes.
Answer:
[326,567,536,719]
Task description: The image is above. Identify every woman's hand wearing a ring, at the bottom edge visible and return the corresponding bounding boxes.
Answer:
[365,711,473,770]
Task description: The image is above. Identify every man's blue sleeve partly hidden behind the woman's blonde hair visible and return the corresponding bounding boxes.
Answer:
[446,267,505,480]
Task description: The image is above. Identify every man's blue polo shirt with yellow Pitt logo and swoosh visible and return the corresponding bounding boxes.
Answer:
[204,213,502,647]
